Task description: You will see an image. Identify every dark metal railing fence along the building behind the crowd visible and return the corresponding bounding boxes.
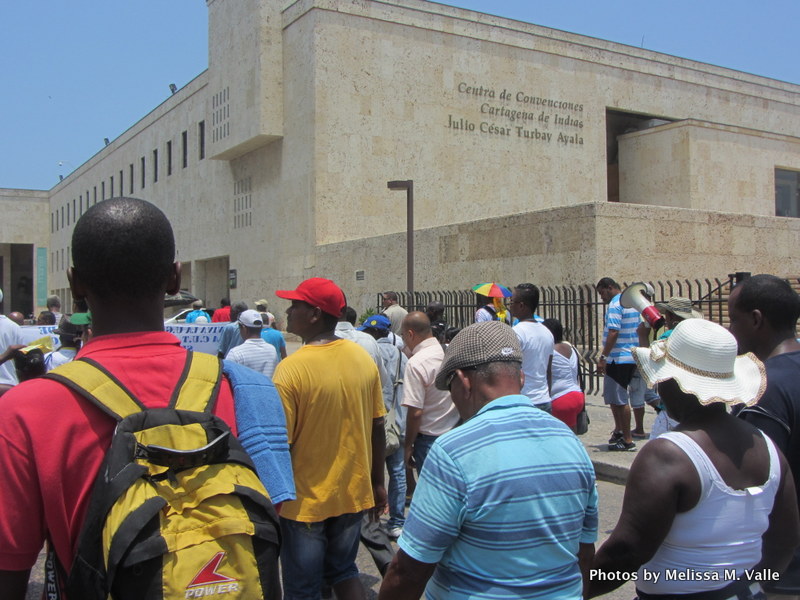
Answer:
[376,273,749,393]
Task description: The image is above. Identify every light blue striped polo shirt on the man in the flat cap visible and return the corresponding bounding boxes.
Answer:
[398,395,597,600]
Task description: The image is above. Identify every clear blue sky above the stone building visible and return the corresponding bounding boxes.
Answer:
[0,0,800,189]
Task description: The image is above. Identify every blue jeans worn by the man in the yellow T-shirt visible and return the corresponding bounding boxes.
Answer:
[281,512,363,600]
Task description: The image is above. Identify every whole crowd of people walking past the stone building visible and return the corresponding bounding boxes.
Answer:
[0,198,800,600]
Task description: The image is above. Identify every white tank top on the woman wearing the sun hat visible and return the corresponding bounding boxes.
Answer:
[636,431,780,594]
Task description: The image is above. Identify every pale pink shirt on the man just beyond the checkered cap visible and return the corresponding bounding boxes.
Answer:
[403,337,459,436]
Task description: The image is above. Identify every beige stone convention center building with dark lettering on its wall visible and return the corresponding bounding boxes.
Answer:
[0,0,800,310]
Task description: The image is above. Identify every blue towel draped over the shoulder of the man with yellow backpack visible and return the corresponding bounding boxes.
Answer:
[222,360,296,504]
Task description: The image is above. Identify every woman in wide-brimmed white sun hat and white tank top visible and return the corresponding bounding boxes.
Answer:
[590,319,800,600]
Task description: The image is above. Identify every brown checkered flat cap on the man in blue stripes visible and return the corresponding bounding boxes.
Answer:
[435,321,522,390]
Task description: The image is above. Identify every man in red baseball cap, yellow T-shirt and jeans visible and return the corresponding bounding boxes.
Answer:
[273,277,386,600]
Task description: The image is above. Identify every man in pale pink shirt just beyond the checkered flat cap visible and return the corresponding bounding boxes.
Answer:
[402,312,459,471]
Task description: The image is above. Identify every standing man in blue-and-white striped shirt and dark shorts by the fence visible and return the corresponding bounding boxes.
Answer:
[595,277,649,452]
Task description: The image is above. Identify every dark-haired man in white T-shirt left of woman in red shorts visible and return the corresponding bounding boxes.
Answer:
[511,283,554,412]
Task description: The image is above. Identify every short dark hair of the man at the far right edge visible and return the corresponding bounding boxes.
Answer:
[734,274,800,331]
